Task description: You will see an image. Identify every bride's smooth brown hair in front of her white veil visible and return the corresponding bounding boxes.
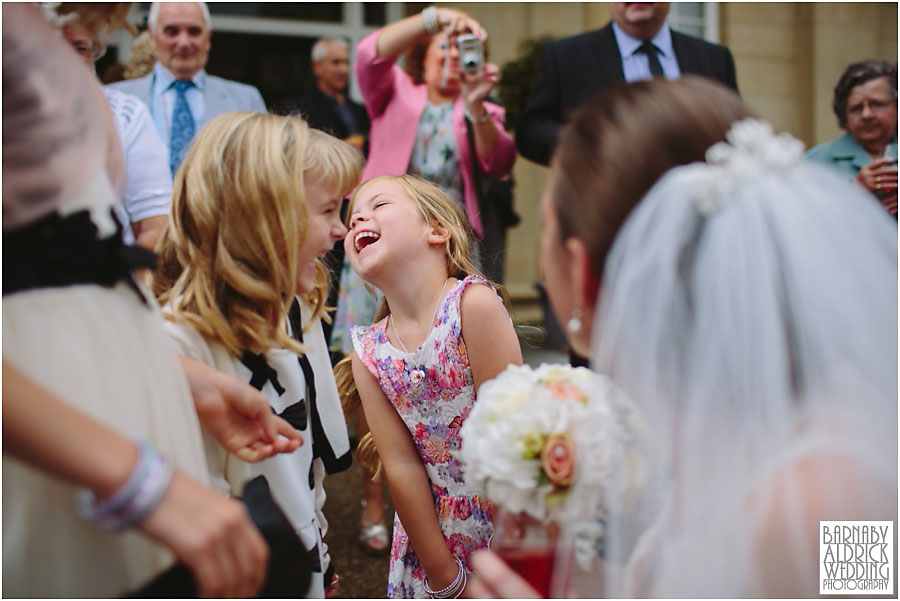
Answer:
[550,75,753,292]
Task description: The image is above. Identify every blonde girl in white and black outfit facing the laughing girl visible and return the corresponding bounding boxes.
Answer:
[153,112,362,597]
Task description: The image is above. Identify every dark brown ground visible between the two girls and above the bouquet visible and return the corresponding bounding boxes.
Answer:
[325,330,568,599]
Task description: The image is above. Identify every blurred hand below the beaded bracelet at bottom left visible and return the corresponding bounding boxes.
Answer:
[140,471,269,597]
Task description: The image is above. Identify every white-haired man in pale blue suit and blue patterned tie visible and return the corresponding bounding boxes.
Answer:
[109,2,266,174]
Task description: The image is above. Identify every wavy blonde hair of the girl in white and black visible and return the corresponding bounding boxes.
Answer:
[151,112,362,356]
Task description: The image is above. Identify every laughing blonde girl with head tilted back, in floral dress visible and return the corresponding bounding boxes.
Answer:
[344,175,522,598]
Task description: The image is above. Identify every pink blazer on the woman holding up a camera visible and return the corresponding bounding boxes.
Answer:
[355,30,516,238]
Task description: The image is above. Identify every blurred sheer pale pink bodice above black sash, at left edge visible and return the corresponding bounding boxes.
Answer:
[3,3,111,231]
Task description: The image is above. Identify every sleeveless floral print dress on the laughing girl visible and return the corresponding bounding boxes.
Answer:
[352,275,493,599]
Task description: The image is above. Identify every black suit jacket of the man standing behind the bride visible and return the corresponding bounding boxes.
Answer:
[516,23,737,165]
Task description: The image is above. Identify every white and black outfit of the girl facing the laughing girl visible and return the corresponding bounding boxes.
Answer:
[166,300,351,598]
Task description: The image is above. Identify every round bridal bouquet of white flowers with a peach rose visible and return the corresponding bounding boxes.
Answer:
[458,364,646,521]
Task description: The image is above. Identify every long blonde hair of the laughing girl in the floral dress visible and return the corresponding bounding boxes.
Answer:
[334,174,509,480]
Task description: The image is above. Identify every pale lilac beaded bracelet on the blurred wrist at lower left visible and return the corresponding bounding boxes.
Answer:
[77,441,173,532]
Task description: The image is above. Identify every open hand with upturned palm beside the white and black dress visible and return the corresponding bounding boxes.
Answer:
[179,356,303,462]
